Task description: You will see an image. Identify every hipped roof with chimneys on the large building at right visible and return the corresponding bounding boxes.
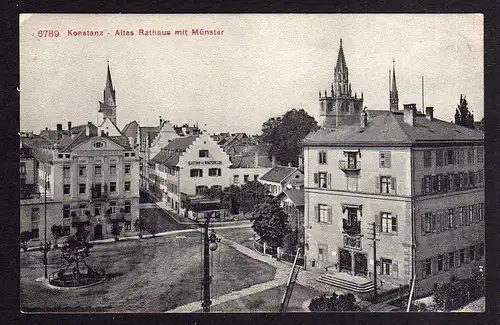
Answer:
[303,111,484,146]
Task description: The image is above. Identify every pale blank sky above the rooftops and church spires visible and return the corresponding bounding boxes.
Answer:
[20,14,484,134]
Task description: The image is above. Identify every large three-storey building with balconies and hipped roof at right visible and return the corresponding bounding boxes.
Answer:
[304,105,484,296]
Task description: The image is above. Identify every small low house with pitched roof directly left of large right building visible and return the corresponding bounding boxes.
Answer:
[259,166,304,196]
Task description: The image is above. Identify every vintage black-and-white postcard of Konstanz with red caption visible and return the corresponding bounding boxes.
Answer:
[19,14,485,313]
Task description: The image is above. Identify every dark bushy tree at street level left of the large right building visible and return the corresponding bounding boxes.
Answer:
[251,197,289,247]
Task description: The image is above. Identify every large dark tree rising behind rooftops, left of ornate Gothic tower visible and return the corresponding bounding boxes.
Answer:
[262,109,318,166]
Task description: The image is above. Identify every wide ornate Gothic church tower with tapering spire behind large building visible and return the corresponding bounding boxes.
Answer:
[319,39,363,129]
